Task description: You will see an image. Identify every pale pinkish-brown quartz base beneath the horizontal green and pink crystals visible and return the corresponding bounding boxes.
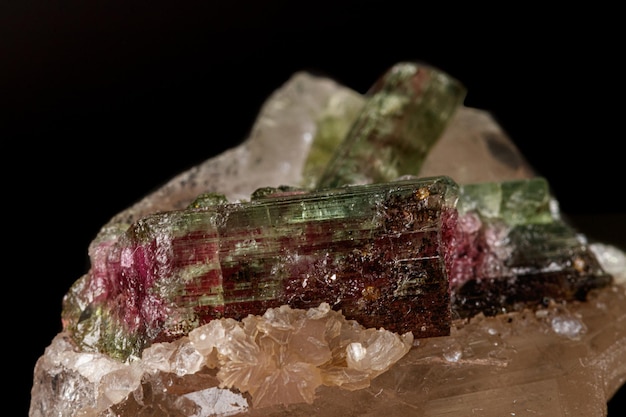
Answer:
[29,280,626,417]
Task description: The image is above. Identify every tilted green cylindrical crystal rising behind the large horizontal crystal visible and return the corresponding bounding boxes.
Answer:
[317,62,466,189]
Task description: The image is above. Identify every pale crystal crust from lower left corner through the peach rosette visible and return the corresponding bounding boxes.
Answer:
[31,303,413,417]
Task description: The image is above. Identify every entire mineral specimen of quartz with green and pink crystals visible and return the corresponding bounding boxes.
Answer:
[30,62,626,417]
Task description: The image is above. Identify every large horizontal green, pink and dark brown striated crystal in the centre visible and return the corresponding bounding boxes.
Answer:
[63,177,458,359]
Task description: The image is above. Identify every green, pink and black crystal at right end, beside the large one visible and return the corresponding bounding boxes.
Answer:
[450,177,612,317]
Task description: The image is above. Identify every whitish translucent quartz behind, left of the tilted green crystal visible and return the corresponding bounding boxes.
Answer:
[103,71,364,224]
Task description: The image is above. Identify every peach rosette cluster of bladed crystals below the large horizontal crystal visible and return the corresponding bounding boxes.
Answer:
[188,303,413,408]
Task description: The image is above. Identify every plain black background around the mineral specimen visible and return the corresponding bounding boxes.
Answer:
[0,0,626,416]
